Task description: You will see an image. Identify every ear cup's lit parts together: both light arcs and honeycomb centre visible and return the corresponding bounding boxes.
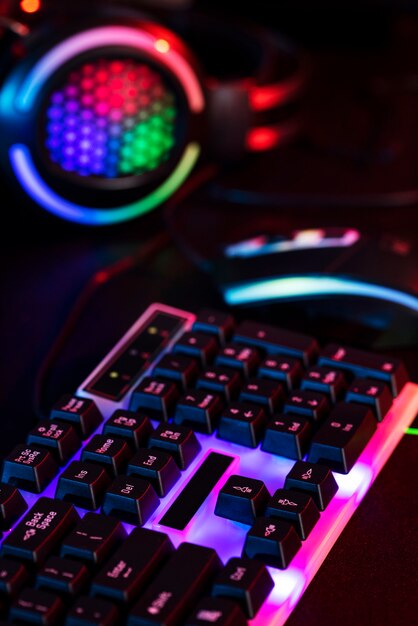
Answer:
[9,26,205,224]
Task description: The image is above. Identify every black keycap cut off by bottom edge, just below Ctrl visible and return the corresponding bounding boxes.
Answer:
[185,598,248,626]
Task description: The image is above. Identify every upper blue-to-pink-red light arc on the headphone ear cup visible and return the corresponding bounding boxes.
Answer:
[16,26,205,113]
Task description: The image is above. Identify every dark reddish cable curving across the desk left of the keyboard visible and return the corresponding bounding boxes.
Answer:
[33,233,169,419]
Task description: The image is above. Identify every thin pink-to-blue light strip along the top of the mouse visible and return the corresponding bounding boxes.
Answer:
[225,228,360,258]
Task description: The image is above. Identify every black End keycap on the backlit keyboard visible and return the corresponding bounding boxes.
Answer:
[126,448,181,498]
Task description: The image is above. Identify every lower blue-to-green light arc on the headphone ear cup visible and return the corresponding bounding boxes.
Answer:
[9,143,200,226]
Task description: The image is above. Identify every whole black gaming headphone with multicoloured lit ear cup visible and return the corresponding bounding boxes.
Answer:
[0,0,304,225]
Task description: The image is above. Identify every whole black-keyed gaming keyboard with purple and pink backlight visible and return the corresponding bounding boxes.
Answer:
[0,304,418,626]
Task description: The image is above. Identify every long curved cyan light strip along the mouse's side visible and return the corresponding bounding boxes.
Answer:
[224,276,418,313]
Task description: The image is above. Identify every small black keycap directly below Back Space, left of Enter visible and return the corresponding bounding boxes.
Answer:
[36,556,90,596]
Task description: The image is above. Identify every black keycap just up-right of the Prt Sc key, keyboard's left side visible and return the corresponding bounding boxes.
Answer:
[26,420,80,465]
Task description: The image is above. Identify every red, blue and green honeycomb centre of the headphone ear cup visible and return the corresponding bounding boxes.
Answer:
[45,58,178,179]
